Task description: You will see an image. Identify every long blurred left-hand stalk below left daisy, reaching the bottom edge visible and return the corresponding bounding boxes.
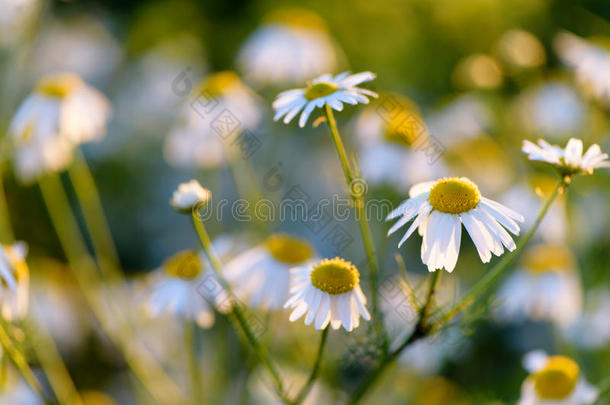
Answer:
[39,174,187,404]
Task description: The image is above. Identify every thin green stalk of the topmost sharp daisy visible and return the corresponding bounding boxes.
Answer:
[324,104,385,341]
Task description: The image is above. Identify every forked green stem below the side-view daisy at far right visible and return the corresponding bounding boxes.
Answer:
[348,179,568,405]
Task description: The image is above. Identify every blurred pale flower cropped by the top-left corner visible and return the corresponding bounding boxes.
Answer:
[0,0,38,47]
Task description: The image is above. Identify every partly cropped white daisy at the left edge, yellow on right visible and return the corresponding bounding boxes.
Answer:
[0,242,30,321]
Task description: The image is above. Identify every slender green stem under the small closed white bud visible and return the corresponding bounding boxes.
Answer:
[192,210,290,403]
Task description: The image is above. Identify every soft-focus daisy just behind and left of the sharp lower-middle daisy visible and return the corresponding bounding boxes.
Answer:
[223,234,314,309]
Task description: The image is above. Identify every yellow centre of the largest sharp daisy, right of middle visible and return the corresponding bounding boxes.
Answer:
[428,177,481,214]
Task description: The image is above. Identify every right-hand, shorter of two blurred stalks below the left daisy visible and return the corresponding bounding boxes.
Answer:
[68,150,123,282]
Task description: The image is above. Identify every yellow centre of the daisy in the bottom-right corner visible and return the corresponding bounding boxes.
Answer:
[533,356,580,400]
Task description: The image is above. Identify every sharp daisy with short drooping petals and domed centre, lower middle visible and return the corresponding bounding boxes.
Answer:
[284,257,371,332]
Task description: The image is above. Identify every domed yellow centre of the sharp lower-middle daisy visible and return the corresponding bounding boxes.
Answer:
[310,257,360,295]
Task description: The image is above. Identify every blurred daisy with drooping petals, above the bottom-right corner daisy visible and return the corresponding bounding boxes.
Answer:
[495,244,582,328]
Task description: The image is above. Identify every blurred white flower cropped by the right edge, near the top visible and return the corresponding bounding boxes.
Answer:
[555,32,610,105]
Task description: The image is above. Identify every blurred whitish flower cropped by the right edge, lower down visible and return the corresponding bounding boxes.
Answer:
[566,288,610,349]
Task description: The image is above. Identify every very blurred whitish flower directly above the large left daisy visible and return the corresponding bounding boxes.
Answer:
[27,15,123,85]
